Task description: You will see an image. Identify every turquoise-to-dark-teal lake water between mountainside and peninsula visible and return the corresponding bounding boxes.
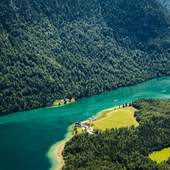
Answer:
[0,77,170,170]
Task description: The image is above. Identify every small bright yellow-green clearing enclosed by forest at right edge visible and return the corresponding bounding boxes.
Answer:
[149,148,170,164]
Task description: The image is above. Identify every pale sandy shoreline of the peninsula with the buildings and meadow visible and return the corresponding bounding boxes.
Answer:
[47,105,123,170]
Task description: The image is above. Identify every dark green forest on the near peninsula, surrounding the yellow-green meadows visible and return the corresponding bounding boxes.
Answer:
[63,99,170,170]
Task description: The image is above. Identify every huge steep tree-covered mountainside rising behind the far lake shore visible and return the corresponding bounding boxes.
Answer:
[0,0,170,115]
